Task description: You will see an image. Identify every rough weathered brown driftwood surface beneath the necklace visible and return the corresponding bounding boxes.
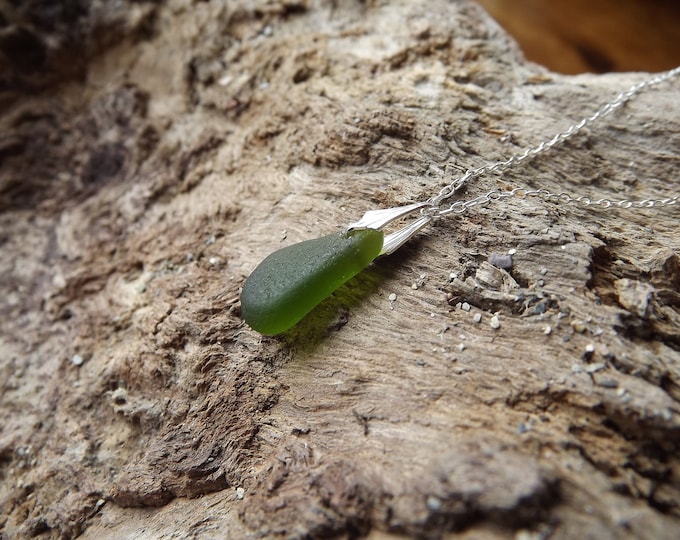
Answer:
[0,0,680,539]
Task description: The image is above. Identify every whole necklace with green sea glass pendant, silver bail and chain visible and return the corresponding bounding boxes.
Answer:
[241,66,680,335]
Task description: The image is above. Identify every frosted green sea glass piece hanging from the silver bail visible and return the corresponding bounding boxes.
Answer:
[241,229,383,335]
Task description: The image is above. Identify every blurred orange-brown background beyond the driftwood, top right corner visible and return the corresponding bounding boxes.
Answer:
[477,0,680,74]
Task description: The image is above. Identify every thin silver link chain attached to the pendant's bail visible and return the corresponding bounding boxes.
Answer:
[423,66,680,218]
